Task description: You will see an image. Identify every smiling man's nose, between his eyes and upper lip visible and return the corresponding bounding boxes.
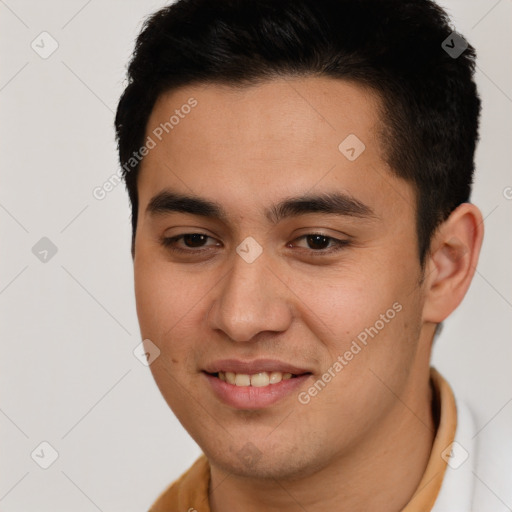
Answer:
[208,255,293,342]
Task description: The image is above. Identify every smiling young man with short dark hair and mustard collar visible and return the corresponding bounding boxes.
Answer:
[116,0,506,512]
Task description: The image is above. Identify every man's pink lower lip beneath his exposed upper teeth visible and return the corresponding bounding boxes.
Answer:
[203,372,311,410]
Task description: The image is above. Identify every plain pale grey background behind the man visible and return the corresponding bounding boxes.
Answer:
[0,0,512,512]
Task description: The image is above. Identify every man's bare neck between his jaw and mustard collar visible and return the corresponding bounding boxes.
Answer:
[210,367,436,512]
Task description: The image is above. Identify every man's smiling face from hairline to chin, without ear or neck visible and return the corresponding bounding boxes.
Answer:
[134,77,428,478]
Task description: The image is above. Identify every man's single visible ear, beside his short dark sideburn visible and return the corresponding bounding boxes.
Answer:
[423,203,484,323]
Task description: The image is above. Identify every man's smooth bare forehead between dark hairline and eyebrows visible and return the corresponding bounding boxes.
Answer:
[138,77,414,224]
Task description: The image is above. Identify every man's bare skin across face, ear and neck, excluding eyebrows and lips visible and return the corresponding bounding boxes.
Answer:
[134,77,483,512]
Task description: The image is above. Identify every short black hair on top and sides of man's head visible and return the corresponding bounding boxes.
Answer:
[115,0,480,265]
